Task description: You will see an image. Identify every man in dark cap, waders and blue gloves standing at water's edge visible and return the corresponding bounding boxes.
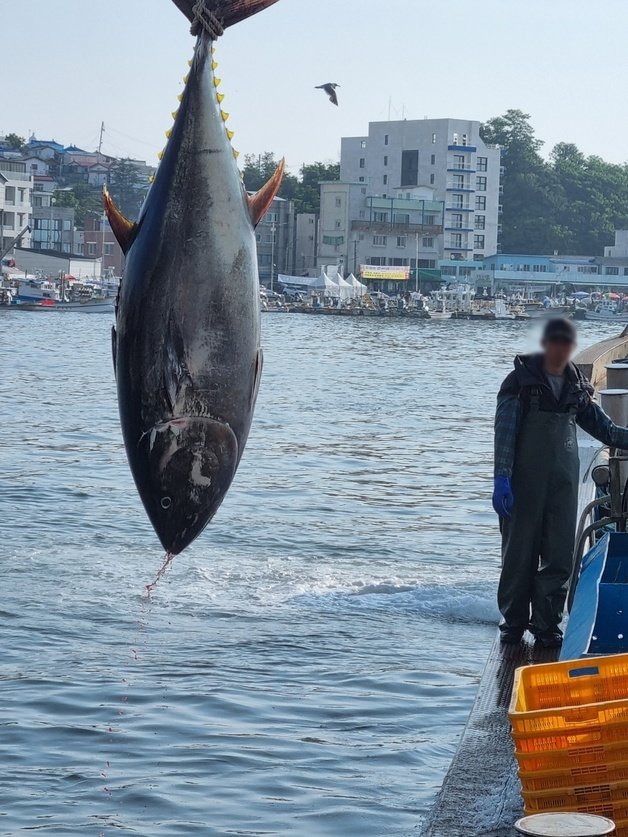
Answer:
[493,319,628,648]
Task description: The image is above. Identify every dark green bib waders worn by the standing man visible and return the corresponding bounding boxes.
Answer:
[497,395,580,634]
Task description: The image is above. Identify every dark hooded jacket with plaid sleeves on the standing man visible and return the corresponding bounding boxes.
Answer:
[495,354,628,477]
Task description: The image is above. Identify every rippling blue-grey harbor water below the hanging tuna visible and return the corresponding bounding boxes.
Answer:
[0,313,617,837]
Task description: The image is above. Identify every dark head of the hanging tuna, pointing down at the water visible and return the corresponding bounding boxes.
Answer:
[134,416,238,555]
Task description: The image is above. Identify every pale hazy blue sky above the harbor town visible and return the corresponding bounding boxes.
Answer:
[0,0,628,171]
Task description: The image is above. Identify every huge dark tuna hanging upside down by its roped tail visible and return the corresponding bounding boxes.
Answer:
[105,0,283,555]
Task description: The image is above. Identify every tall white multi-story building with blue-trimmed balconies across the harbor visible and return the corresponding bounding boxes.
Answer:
[318,119,501,270]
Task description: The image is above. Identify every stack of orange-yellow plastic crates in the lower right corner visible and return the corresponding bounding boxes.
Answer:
[510,654,628,837]
